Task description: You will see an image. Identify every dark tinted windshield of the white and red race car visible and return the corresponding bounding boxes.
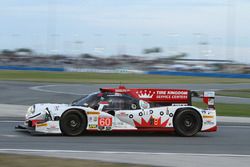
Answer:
[72,92,101,107]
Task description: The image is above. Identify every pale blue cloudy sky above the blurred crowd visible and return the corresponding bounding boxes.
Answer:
[0,0,250,63]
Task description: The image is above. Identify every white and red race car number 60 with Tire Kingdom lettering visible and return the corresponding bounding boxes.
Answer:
[16,86,217,136]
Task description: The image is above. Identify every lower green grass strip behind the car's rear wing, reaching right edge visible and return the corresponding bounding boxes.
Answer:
[193,102,250,117]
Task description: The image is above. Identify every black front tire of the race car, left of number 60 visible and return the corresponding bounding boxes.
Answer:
[60,110,87,136]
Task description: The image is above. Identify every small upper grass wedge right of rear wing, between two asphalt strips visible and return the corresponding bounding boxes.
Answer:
[216,89,250,98]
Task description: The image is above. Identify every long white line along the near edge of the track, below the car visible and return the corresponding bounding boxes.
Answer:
[0,149,250,158]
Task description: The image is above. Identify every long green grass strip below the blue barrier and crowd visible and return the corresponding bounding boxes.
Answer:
[0,71,250,84]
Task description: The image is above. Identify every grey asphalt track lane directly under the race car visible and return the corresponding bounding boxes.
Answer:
[0,119,250,155]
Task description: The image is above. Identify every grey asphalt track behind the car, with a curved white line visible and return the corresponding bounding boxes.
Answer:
[0,81,250,105]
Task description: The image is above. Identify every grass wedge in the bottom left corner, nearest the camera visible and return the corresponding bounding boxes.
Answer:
[0,154,145,167]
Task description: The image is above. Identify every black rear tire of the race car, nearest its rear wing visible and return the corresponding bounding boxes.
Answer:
[174,109,202,137]
